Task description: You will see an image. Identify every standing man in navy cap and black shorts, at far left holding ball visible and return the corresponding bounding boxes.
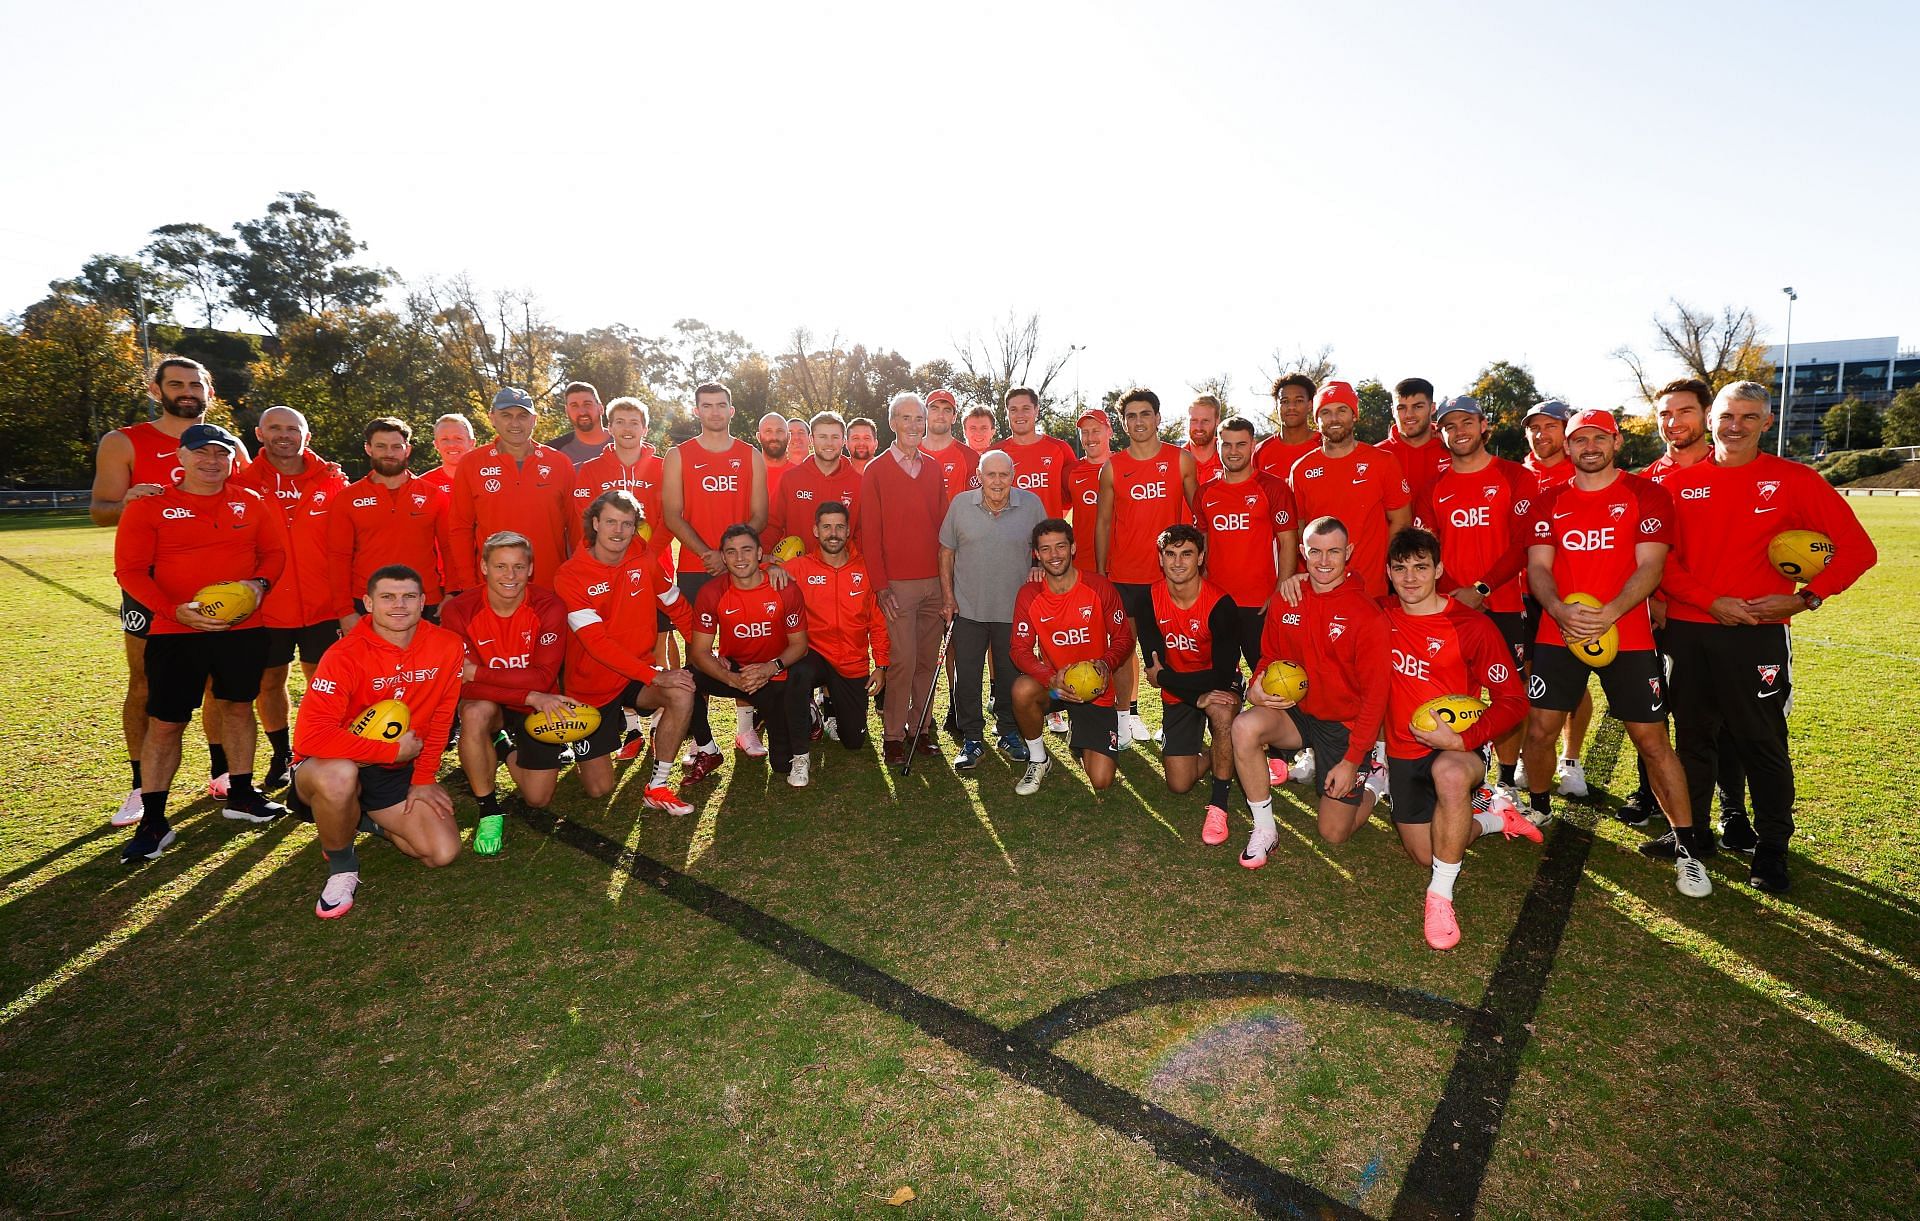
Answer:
[113,424,286,864]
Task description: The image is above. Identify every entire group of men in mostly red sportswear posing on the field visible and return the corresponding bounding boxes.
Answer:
[92,357,1876,948]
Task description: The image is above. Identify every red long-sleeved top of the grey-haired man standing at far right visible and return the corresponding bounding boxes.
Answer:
[1661,453,1880,624]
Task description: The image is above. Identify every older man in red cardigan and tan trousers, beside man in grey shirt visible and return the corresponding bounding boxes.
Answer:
[860,394,947,764]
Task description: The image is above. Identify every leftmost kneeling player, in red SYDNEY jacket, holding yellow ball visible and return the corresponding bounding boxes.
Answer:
[288,564,472,920]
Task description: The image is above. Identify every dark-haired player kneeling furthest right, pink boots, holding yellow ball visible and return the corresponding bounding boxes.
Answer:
[1386,528,1540,950]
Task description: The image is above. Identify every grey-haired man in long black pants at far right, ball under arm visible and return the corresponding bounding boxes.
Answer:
[1661,382,1880,893]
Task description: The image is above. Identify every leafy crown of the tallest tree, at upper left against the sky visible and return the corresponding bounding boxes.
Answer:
[209,190,388,328]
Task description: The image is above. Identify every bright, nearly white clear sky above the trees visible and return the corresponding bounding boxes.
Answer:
[0,0,1920,407]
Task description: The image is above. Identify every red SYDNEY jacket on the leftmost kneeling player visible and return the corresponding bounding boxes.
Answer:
[294,616,467,785]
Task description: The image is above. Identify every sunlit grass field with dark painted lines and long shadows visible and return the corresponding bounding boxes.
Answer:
[0,499,1920,1217]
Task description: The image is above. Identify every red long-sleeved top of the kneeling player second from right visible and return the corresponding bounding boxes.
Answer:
[1254,572,1390,764]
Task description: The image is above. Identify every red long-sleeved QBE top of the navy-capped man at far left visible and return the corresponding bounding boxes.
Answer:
[113,480,286,635]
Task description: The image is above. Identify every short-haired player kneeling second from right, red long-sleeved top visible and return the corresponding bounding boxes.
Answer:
[1233,514,1388,870]
